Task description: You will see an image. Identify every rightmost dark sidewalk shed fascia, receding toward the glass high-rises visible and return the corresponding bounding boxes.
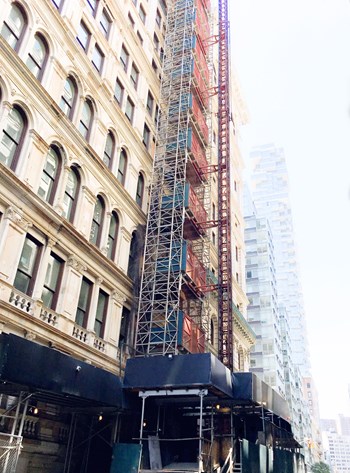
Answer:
[232,372,290,422]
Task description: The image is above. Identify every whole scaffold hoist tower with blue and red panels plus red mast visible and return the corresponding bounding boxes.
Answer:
[135,0,233,370]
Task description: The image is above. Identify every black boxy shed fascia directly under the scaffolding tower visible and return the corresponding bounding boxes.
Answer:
[124,353,232,397]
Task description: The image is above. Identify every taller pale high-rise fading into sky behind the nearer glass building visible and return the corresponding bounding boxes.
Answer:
[250,144,310,375]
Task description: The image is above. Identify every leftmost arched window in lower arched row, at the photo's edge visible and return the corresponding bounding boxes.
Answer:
[0,105,27,171]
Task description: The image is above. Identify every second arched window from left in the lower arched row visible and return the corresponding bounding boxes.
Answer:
[38,145,62,204]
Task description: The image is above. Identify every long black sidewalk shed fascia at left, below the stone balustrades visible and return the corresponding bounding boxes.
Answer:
[0,333,124,409]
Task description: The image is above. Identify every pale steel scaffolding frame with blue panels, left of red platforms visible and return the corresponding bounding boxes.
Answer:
[135,0,209,356]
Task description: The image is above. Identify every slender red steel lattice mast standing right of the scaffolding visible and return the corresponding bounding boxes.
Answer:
[218,0,233,370]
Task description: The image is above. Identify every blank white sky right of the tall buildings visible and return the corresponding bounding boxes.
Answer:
[228,0,350,417]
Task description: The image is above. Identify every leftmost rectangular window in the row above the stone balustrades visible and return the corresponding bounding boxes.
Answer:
[13,235,42,296]
